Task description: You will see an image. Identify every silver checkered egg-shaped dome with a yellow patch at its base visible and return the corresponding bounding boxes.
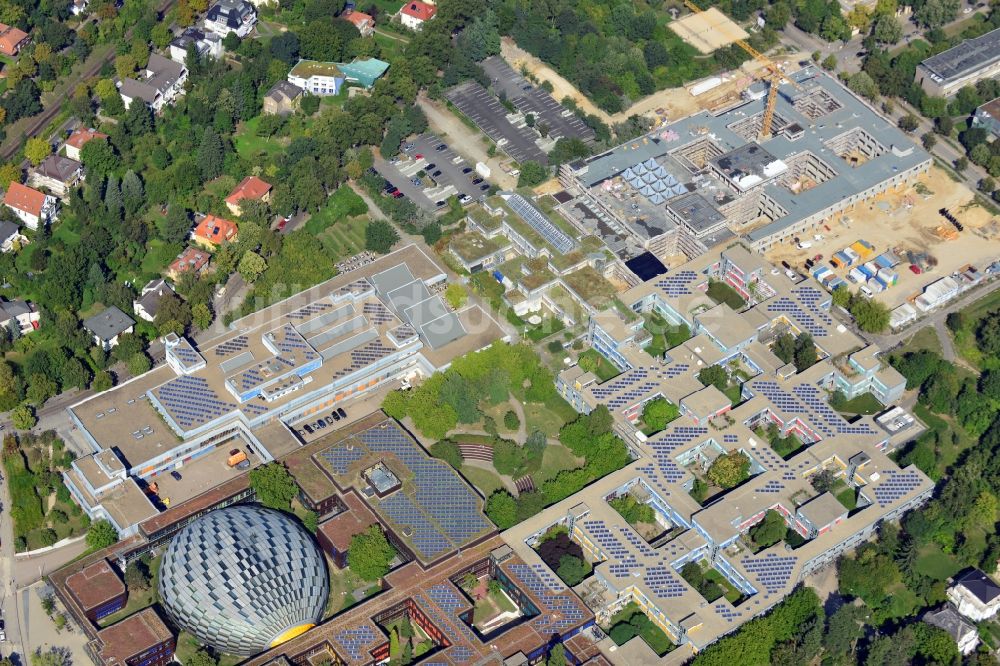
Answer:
[159,505,329,656]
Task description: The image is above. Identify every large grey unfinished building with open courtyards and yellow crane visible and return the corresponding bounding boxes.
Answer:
[560,67,932,257]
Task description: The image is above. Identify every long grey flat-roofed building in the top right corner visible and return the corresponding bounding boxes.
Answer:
[916,28,1000,97]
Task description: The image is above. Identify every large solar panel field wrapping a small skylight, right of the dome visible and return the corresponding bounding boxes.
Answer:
[320,422,493,561]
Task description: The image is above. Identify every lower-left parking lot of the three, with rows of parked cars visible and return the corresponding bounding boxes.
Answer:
[375,134,489,211]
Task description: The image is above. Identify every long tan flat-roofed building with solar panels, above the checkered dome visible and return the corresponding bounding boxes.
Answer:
[64,245,505,533]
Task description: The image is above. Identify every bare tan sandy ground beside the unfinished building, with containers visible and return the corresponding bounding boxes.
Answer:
[766,167,1000,308]
